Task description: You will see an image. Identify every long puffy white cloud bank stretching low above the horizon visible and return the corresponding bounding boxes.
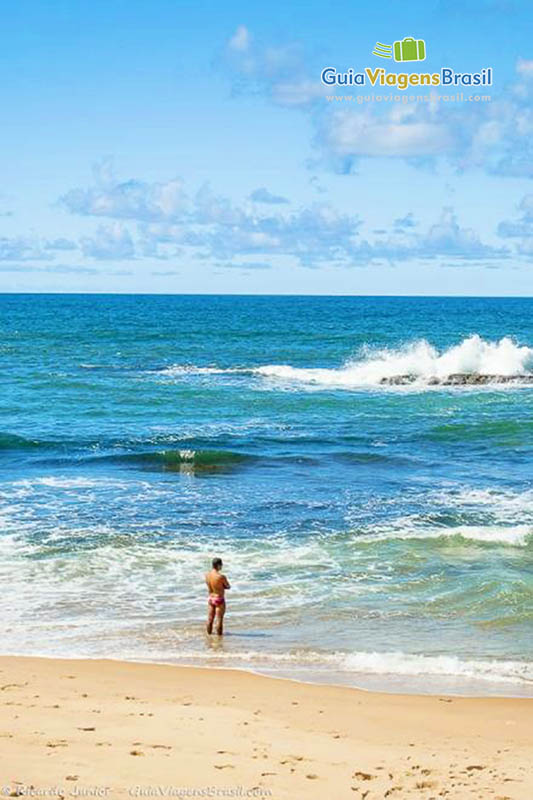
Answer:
[60,167,512,269]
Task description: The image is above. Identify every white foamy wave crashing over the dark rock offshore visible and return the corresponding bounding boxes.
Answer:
[254,334,533,388]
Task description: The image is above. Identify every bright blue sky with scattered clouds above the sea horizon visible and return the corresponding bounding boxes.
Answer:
[0,0,533,296]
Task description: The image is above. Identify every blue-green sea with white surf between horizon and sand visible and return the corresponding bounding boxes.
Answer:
[0,295,533,696]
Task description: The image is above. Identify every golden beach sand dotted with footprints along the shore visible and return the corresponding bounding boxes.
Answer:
[0,657,533,800]
